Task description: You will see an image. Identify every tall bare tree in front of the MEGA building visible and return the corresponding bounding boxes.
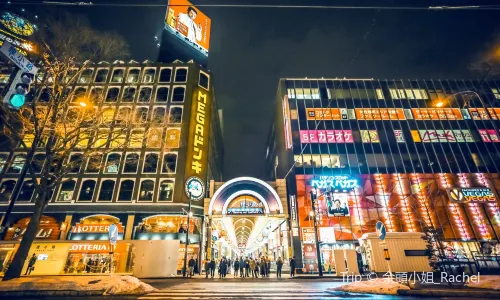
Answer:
[0,14,142,280]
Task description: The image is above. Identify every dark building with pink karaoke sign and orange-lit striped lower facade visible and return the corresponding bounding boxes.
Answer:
[266,78,500,272]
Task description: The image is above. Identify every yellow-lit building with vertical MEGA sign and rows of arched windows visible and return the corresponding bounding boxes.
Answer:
[0,61,223,274]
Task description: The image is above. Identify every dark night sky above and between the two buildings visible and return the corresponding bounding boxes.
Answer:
[17,0,500,180]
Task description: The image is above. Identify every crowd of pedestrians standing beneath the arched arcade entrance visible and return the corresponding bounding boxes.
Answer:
[205,256,295,278]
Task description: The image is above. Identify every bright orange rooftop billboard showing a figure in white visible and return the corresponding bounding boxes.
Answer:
[165,0,211,56]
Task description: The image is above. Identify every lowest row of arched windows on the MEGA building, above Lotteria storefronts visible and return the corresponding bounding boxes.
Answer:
[0,178,175,202]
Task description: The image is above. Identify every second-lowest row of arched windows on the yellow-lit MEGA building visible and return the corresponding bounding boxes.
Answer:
[0,152,177,174]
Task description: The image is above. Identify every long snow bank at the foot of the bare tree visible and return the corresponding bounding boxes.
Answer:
[0,275,156,295]
